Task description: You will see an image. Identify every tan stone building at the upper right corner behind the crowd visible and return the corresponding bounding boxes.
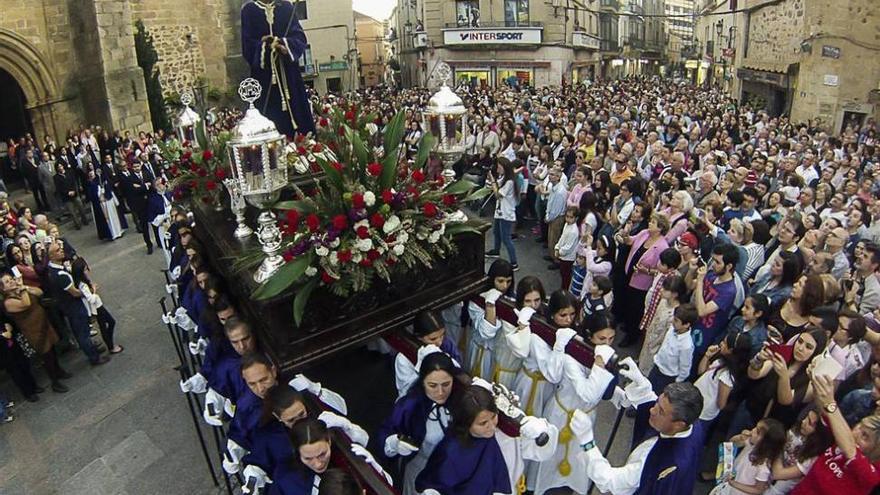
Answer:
[696,0,880,132]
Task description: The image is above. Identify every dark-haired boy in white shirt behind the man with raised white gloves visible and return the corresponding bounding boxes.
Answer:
[648,304,699,395]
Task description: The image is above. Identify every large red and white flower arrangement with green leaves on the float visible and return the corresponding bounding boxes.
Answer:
[253,101,488,325]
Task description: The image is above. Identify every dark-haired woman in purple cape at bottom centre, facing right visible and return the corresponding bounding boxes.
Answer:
[416,385,512,495]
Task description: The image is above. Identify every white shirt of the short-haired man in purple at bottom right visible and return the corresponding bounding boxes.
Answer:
[579,427,693,495]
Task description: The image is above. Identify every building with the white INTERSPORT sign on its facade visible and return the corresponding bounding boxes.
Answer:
[394,0,600,87]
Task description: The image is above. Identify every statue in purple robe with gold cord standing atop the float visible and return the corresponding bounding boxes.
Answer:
[241,0,315,137]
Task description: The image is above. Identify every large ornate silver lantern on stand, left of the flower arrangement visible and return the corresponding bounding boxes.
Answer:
[227,78,287,283]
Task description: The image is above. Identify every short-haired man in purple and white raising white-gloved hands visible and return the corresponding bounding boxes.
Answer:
[571,358,704,495]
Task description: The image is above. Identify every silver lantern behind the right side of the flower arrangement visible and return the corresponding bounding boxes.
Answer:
[423,62,467,184]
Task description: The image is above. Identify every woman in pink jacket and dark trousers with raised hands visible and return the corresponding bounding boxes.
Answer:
[616,214,669,347]
